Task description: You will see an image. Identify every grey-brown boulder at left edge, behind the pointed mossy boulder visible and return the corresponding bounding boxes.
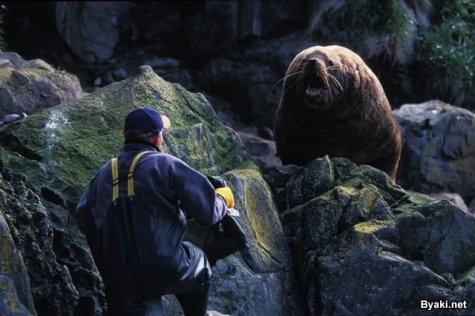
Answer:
[0,52,83,118]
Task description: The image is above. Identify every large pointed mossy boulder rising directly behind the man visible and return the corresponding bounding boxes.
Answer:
[0,66,301,315]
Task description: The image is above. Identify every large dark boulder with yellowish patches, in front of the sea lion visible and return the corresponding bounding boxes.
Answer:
[266,157,475,315]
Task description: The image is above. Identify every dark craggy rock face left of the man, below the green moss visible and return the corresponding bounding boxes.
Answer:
[0,176,104,315]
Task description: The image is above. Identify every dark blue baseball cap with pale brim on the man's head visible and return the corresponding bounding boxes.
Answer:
[124,106,170,133]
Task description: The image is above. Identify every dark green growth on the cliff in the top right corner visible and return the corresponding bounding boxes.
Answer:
[416,0,475,104]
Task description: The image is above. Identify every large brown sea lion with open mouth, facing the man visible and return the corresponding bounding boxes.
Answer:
[274,45,401,181]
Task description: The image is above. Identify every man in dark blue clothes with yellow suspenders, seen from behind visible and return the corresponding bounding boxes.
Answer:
[75,107,234,316]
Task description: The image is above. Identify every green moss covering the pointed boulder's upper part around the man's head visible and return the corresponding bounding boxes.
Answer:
[0,70,253,210]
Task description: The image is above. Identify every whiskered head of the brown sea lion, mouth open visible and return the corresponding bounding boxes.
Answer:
[284,46,358,110]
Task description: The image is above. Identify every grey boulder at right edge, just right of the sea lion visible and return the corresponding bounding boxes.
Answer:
[394,100,475,204]
